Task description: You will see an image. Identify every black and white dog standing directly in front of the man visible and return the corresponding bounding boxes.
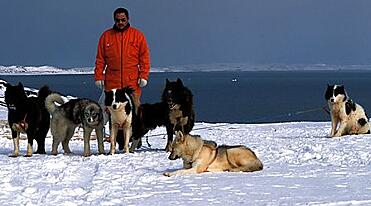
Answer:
[104,87,138,154]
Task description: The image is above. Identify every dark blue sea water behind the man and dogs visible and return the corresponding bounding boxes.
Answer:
[0,71,371,123]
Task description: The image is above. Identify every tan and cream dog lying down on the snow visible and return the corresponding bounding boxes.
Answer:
[164,131,263,177]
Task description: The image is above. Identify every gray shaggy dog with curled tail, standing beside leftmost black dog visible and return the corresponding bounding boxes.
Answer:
[45,93,104,156]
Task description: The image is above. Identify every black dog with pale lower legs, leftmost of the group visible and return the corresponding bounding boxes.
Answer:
[5,83,50,157]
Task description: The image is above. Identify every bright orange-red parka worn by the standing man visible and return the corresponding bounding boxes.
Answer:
[94,26,150,97]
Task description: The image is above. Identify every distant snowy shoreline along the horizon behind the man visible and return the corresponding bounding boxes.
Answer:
[0,63,371,76]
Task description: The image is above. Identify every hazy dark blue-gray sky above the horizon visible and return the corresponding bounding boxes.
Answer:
[0,0,371,67]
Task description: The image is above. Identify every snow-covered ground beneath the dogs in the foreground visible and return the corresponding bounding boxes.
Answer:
[0,71,371,206]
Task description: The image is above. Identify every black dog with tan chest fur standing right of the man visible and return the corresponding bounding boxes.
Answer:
[130,78,195,152]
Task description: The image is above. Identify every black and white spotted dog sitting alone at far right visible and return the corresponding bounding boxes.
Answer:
[325,85,370,137]
